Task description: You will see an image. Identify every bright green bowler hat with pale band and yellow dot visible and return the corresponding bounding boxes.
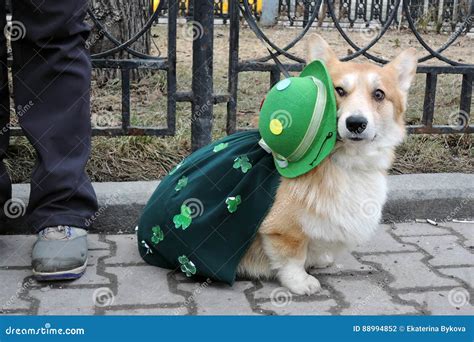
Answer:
[259,60,337,178]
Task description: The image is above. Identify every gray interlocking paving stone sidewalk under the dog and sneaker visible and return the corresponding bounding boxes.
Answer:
[0,223,474,315]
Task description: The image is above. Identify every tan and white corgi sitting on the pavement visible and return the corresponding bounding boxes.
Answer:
[237,35,417,295]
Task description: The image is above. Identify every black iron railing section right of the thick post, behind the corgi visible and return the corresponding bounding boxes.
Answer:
[227,0,474,134]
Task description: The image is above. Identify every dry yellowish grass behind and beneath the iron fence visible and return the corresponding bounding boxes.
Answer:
[7,27,474,182]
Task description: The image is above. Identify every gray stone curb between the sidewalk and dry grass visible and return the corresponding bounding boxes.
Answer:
[0,173,474,234]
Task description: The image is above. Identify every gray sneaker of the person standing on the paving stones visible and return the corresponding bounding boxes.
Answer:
[32,226,87,280]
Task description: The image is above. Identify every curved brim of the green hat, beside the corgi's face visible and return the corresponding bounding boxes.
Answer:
[275,60,337,178]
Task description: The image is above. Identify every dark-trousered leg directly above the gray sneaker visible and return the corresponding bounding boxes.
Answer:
[12,0,97,231]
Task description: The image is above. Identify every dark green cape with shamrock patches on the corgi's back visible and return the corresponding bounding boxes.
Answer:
[138,131,280,284]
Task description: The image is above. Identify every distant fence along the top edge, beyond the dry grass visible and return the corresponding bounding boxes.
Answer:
[154,0,472,31]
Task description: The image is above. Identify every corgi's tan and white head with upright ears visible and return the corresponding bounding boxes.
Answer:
[308,35,417,148]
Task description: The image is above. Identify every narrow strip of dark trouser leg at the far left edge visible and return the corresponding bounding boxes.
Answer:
[0,1,12,226]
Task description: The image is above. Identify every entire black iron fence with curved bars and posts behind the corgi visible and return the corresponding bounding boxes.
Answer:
[8,0,474,149]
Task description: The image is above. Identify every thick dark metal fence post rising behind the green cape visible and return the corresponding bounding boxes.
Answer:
[191,0,214,150]
